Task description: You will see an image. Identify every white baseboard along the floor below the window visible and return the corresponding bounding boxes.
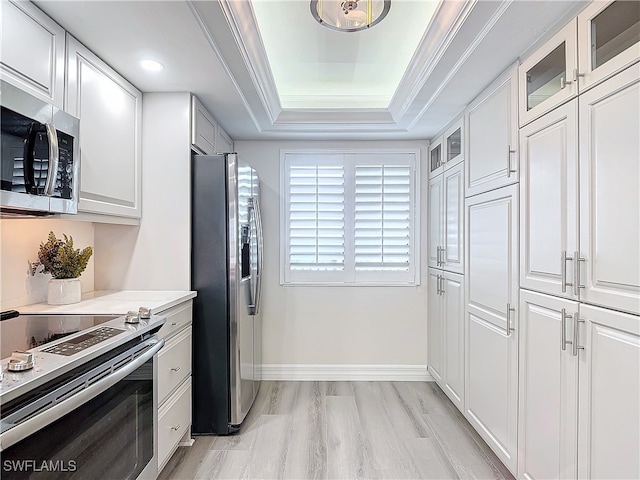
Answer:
[262,363,433,382]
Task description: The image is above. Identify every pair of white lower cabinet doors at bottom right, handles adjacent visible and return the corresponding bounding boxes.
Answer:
[518,290,640,479]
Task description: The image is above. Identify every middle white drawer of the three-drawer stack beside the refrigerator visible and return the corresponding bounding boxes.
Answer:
[158,327,191,404]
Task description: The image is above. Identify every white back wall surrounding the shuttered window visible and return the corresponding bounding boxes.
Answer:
[235,141,427,370]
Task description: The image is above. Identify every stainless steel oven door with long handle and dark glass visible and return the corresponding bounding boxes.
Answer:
[0,338,164,480]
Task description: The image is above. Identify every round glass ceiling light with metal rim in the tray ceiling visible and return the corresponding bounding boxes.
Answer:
[311,0,391,32]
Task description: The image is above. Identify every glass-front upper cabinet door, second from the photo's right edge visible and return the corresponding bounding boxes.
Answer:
[518,19,578,127]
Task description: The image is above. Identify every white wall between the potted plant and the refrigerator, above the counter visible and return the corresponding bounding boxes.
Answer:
[95,93,191,290]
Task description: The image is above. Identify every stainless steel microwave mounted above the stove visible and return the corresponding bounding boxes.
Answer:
[0,81,80,216]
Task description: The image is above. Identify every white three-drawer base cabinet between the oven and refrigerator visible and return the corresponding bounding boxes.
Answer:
[158,300,193,473]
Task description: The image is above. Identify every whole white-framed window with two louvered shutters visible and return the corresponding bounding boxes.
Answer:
[280,151,419,285]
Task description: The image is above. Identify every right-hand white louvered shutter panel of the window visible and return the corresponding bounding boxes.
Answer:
[354,163,412,272]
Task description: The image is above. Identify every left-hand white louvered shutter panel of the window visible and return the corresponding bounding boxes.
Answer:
[288,165,345,271]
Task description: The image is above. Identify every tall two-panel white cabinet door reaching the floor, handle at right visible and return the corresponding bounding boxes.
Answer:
[465,185,518,473]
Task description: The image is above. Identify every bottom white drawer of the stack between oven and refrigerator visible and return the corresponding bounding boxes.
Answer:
[158,378,191,471]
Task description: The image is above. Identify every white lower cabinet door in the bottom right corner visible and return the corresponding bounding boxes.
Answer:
[578,304,640,479]
